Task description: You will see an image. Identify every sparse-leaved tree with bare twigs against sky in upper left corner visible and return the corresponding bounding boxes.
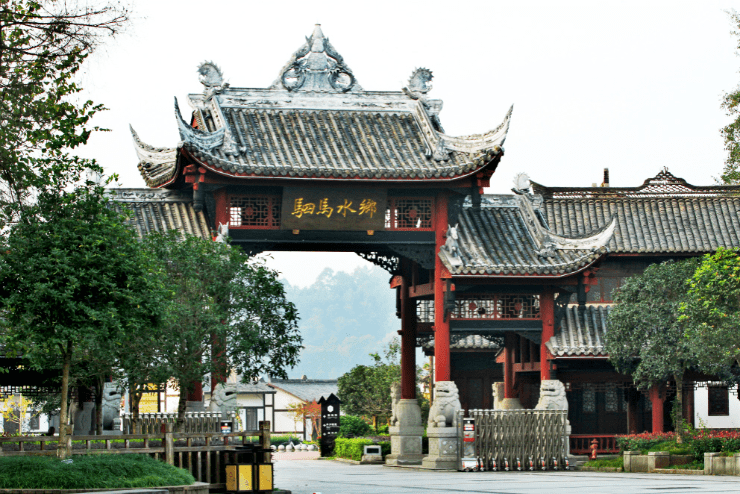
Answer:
[0,0,128,220]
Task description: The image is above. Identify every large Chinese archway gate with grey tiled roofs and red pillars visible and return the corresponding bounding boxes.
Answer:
[118,26,613,466]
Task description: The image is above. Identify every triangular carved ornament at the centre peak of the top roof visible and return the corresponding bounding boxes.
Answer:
[272,24,362,93]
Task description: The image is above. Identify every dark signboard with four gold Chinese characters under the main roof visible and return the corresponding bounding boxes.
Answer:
[280,187,388,231]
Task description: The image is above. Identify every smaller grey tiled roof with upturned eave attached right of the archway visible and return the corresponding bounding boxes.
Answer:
[439,195,614,276]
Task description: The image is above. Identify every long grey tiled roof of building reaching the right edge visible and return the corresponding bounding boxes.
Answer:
[535,171,740,253]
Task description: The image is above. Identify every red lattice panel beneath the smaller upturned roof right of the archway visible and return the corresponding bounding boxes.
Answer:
[452,294,541,319]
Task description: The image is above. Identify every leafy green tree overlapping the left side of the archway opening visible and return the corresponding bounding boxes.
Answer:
[139,232,302,427]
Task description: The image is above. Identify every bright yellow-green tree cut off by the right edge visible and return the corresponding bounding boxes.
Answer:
[681,248,740,379]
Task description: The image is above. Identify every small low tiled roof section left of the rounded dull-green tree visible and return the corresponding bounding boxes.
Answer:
[545,305,611,357]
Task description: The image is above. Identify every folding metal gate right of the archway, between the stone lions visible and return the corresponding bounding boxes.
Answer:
[457,410,569,471]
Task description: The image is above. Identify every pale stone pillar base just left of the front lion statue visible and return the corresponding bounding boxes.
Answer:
[385,383,424,465]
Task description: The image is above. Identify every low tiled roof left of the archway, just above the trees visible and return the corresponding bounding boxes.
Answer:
[108,189,211,238]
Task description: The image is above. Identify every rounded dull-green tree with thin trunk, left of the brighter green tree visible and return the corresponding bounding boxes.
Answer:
[606,259,699,436]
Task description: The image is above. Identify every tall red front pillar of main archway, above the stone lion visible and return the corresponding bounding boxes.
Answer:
[434,193,452,382]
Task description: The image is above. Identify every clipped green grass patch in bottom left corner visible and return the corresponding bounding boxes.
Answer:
[0,454,195,489]
